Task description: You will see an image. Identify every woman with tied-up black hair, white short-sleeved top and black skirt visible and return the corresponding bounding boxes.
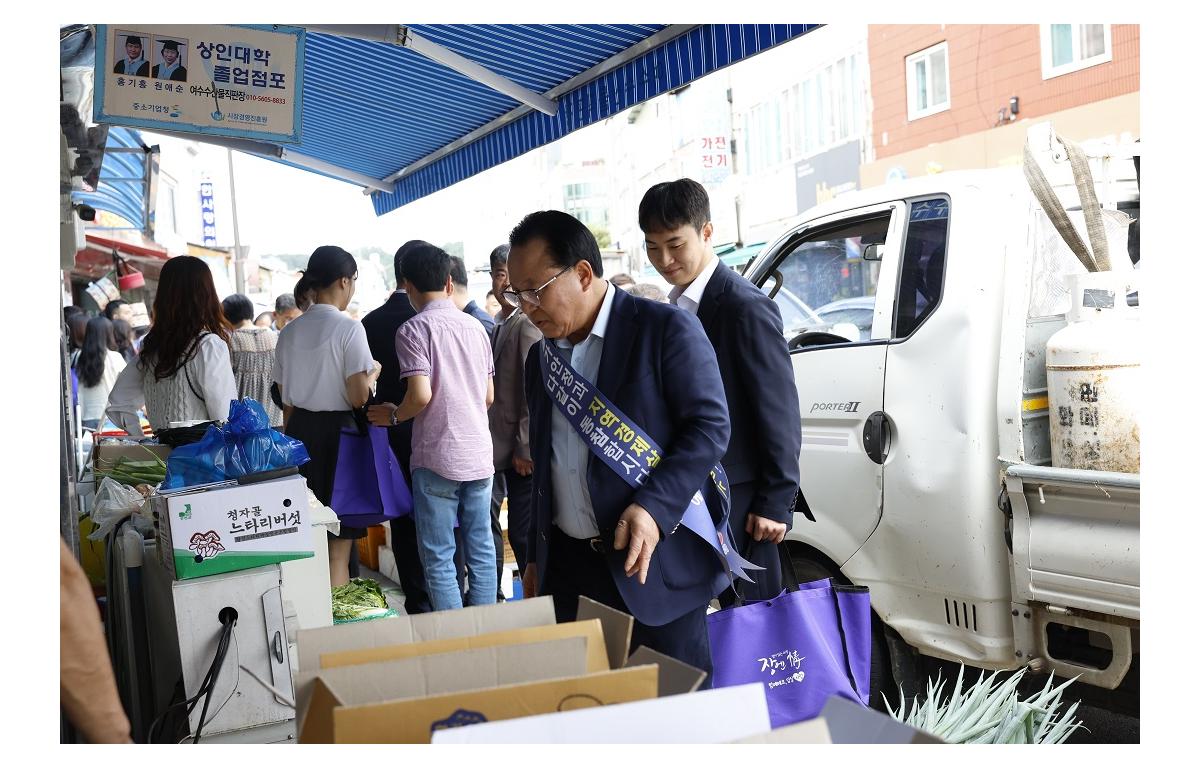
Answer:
[272,245,380,587]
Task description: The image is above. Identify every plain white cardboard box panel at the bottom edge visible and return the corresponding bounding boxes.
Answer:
[433,683,770,744]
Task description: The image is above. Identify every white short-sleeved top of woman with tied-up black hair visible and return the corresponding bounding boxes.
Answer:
[271,304,374,410]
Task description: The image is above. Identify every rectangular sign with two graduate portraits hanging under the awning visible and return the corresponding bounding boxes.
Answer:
[95,24,305,143]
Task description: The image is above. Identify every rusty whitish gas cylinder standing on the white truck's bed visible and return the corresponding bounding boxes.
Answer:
[1046,272,1146,473]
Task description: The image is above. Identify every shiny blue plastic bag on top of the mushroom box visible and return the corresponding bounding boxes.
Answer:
[162,397,308,491]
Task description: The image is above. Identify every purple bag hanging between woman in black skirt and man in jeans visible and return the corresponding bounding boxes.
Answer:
[329,426,413,528]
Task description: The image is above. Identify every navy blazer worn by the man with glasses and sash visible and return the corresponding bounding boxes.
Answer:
[526,285,730,626]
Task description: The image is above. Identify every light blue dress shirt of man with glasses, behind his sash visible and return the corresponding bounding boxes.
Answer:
[547,283,618,539]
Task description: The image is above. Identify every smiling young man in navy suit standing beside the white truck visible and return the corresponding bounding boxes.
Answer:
[637,179,800,606]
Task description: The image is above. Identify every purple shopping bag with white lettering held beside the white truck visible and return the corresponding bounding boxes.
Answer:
[708,578,871,728]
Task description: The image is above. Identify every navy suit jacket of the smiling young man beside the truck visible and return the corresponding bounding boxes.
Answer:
[697,264,800,530]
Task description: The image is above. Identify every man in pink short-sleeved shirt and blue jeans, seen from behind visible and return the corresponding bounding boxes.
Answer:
[367,246,497,611]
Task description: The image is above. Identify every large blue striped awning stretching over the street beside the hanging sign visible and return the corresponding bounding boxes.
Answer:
[289,24,818,215]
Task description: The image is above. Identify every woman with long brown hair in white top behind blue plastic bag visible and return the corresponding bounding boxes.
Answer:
[108,256,238,436]
